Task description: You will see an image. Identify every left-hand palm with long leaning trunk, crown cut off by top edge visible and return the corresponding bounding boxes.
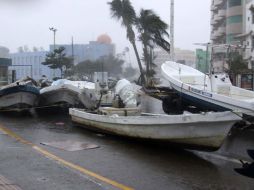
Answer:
[108,0,145,84]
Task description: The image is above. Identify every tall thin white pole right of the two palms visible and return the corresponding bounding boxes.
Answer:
[170,0,175,61]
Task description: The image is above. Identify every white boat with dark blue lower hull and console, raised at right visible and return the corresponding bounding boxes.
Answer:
[161,61,254,116]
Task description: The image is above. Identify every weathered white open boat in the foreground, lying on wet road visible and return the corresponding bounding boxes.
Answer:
[69,108,241,149]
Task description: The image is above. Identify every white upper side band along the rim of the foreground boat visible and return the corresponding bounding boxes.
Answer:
[69,108,241,125]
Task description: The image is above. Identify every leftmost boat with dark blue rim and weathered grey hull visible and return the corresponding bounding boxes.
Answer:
[0,77,40,111]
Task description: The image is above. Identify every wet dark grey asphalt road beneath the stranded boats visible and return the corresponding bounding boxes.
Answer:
[0,107,254,190]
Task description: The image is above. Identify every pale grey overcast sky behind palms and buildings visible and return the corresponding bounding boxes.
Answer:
[0,0,211,52]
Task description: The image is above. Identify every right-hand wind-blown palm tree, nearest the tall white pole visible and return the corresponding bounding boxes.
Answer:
[136,9,170,78]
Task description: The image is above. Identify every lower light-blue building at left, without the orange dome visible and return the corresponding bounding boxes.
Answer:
[9,51,61,80]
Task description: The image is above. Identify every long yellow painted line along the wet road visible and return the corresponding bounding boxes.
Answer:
[0,125,134,190]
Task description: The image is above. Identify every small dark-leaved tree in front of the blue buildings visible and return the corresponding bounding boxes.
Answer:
[42,47,73,77]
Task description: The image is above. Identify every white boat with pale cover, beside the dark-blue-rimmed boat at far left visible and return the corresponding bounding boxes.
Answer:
[40,79,94,106]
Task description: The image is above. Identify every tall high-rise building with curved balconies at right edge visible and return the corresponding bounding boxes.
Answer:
[211,0,254,89]
